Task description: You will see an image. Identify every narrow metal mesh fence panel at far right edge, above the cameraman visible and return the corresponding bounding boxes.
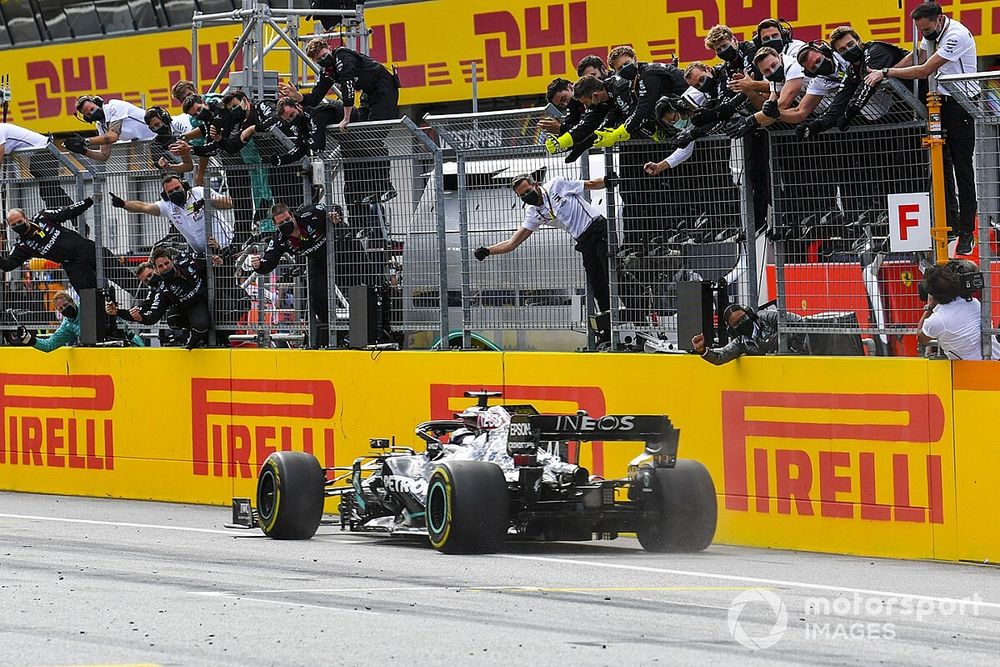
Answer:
[938,72,1000,359]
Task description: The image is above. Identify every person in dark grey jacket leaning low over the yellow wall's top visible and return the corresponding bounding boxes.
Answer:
[691,303,809,366]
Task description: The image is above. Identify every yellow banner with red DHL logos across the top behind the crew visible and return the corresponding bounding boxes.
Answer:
[2,0,1000,132]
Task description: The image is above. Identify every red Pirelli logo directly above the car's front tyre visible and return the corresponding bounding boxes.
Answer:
[191,378,336,479]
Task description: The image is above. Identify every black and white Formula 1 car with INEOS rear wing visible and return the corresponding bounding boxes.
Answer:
[233,391,718,553]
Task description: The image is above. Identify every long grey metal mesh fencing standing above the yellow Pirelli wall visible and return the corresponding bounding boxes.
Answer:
[0,91,968,354]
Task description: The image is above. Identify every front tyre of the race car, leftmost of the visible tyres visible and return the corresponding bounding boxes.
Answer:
[257,452,326,540]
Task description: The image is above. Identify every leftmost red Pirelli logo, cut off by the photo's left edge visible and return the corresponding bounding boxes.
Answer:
[0,373,115,470]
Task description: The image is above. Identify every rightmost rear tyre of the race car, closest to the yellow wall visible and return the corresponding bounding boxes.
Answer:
[636,459,719,552]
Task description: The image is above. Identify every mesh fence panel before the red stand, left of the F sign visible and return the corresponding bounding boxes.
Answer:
[768,82,930,355]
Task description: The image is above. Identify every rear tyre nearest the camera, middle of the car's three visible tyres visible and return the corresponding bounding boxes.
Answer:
[426,461,510,554]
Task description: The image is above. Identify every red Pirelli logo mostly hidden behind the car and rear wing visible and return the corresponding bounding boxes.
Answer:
[430,384,607,475]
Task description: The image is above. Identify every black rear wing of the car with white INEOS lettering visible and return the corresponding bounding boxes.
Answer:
[508,414,681,465]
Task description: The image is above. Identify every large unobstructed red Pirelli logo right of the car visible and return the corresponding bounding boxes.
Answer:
[722,391,944,523]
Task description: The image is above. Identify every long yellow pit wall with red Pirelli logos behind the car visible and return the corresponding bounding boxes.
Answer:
[0,349,1000,561]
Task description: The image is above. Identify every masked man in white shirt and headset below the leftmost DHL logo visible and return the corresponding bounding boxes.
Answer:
[63,95,156,162]
